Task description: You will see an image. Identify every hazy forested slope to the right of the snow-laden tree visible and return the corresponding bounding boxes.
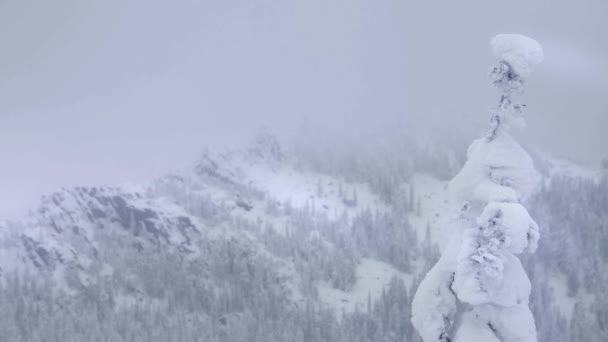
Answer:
[526,176,608,342]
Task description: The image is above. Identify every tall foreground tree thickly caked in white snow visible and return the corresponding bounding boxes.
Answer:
[412,34,543,342]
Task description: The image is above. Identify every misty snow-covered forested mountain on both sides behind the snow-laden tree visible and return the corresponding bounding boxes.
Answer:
[0,134,608,341]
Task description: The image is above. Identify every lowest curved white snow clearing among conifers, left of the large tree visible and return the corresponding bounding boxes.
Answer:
[317,258,413,313]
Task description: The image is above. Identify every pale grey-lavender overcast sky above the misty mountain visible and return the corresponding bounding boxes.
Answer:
[0,0,608,217]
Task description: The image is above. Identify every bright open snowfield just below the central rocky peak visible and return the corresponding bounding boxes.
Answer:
[191,150,388,239]
